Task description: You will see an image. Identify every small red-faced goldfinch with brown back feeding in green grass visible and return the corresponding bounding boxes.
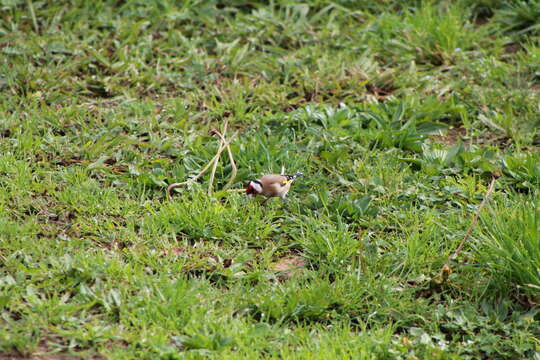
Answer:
[246,172,303,204]
